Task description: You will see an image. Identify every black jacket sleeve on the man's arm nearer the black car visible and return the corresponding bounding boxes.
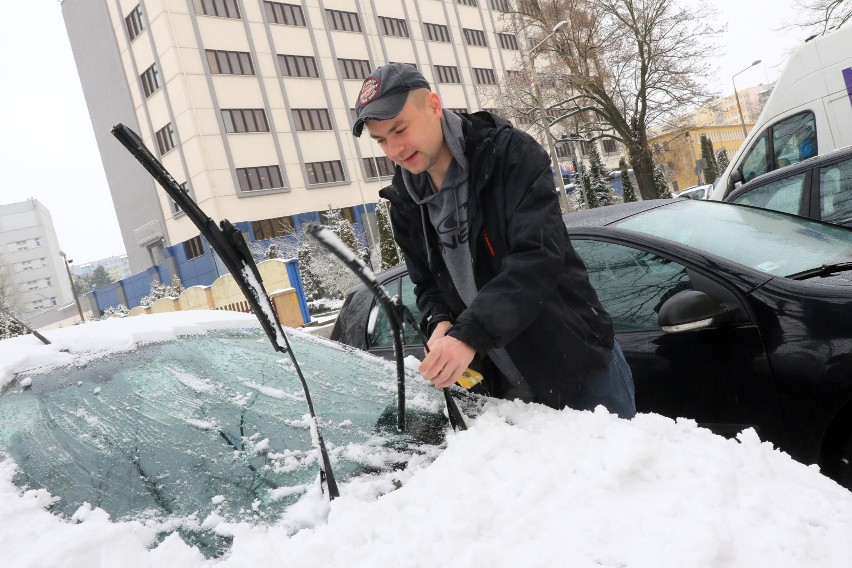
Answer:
[449,129,566,353]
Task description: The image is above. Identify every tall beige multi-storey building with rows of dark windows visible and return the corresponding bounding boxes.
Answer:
[62,0,552,274]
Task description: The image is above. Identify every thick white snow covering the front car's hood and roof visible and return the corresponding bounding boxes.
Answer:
[0,312,852,568]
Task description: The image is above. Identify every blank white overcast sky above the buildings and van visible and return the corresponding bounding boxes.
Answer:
[0,0,806,263]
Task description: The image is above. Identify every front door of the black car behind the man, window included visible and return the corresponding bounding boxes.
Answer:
[572,237,782,439]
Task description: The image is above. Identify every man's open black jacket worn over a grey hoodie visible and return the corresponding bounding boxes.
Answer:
[380,112,613,408]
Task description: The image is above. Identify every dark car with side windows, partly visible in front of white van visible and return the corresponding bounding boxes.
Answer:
[725,146,852,226]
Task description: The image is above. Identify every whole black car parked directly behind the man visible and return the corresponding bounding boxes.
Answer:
[332,199,852,487]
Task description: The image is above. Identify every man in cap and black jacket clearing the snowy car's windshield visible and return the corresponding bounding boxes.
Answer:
[352,63,636,418]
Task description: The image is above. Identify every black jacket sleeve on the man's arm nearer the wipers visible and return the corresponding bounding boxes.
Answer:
[381,187,453,337]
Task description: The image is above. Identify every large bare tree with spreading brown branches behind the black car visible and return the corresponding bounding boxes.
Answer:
[500,0,720,199]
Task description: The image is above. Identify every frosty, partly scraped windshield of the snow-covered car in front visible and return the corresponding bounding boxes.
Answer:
[0,330,446,556]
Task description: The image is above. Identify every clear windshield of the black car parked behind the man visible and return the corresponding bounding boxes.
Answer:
[613,200,852,276]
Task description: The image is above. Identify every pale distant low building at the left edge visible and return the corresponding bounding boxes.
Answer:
[0,199,74,319]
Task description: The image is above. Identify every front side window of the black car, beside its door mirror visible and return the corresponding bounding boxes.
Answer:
[571,239,692,332]
